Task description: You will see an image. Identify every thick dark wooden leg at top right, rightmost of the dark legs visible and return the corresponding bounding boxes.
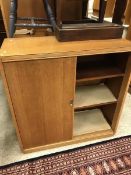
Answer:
[112,0,127,24]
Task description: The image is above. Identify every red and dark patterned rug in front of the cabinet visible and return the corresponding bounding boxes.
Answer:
[0,136,131,175]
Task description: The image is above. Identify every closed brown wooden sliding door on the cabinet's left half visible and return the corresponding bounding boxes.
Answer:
[4,58,75,149]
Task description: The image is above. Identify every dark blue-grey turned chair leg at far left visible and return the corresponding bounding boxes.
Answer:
[9,0,17,38]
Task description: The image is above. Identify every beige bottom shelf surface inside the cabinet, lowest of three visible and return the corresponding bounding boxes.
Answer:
[73,109,111,136]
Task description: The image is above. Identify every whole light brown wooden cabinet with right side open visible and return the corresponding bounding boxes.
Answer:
[0,37,131,153]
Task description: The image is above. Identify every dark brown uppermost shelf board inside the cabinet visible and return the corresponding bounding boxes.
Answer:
[76,65,124,83]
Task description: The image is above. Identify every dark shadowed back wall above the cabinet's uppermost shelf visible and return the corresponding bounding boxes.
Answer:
[77,52,129,72]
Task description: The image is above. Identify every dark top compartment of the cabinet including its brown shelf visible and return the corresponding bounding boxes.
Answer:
[76,53,127,83]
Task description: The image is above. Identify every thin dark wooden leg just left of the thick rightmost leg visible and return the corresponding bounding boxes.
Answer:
[99,0,107,23]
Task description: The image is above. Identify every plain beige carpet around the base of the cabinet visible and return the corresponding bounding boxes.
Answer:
[0,80,131,166]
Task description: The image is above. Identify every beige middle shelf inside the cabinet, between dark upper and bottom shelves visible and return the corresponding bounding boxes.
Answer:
[74,84,117,108]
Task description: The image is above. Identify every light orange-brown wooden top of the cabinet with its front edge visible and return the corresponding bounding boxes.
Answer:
[0,36,131,61]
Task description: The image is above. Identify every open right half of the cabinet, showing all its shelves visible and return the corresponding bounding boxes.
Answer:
[73,53,129,136]
